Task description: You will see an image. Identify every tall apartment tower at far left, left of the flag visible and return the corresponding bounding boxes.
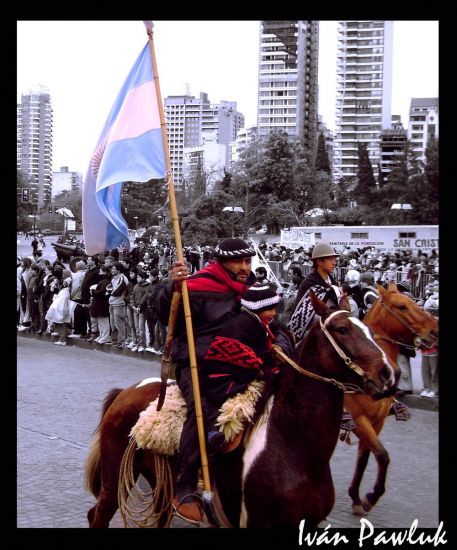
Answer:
[17,87,52,208]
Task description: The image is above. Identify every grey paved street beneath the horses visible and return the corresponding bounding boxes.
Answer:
[17,336,438,528]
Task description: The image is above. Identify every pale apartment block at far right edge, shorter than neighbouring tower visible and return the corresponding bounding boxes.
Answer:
[408,97,439,162]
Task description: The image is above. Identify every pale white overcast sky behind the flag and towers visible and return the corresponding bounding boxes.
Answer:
[17,21,439,176]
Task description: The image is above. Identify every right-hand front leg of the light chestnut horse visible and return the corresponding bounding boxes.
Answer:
[354,418,390,512]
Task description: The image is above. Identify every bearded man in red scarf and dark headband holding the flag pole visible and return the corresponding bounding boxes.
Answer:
[155,238,290,523]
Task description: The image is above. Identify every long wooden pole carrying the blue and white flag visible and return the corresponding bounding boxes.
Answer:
[145,21,211,492]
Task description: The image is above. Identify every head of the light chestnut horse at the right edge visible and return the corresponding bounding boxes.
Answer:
[372,283,439,347]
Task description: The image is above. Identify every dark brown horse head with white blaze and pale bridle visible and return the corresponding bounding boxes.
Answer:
[309,290,396,399]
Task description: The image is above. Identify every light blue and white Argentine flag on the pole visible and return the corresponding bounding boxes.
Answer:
[82,43,166,255]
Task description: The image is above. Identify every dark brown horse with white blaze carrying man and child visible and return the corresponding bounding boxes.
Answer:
[86,295,395,528]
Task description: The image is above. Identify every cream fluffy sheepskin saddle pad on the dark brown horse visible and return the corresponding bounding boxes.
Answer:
[130,380,265,456]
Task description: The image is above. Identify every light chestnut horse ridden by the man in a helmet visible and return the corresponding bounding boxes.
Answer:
[344,283,438,515]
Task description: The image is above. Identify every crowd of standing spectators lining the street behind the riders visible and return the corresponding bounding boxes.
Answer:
[17,239,439,402]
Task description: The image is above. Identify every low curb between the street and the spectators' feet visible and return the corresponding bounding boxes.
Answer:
[18,330,439,412]
